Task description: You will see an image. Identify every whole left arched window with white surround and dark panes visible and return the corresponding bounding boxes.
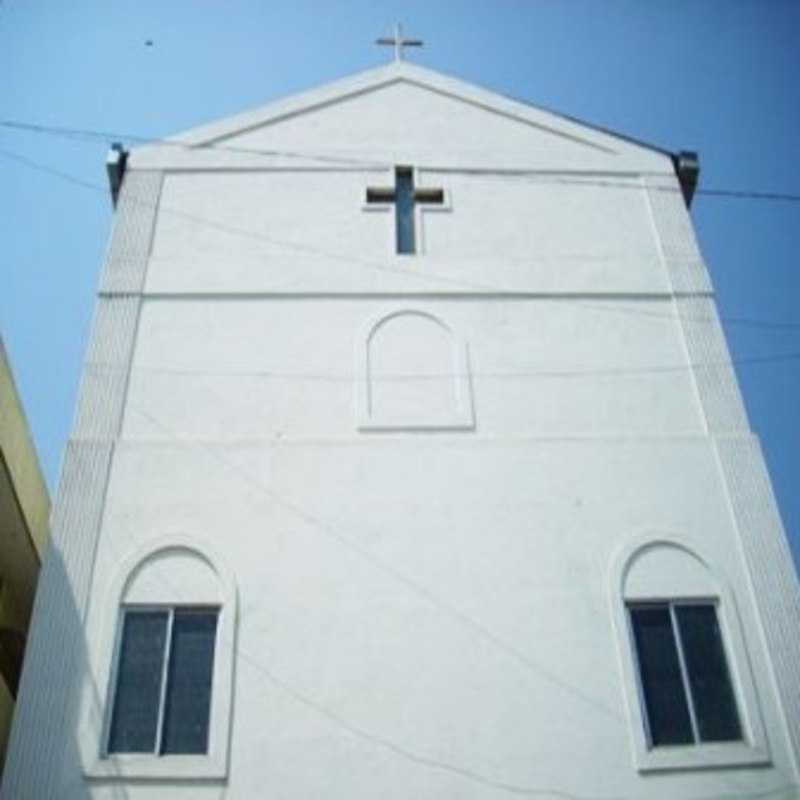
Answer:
[82,540,236,777]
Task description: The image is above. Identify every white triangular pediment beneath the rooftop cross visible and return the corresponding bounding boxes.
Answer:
[137,62,667,171]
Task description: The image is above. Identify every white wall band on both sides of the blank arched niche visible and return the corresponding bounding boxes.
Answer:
[117,298,703,441]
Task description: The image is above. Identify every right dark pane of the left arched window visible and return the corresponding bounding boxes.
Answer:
[161,609,218,753]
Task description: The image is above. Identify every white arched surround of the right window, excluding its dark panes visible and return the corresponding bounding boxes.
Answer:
[610,536,770,772]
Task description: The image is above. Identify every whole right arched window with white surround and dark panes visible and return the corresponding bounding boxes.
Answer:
[615,541,766,770]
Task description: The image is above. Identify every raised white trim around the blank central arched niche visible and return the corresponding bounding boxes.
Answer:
[355,306,475,432]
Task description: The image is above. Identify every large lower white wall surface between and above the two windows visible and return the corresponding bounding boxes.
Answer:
[78,435,789,798]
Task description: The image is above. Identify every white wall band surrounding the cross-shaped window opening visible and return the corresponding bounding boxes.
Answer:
[147,171,670,293]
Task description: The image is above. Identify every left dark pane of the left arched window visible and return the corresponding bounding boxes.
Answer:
[108,611,167,753]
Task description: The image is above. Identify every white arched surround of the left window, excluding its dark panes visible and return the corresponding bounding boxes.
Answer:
[80,536,237,780]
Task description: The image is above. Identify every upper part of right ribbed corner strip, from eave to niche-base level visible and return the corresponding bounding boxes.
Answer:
[647,178,750,434]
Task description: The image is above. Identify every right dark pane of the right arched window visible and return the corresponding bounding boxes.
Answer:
[675,604,742,742]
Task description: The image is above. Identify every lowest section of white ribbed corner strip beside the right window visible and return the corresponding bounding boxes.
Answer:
[715,436,800,765]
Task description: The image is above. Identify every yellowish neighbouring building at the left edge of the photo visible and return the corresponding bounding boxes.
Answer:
[0,339,50,776]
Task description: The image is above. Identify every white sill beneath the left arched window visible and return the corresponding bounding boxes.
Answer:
[83,753,228,781]
